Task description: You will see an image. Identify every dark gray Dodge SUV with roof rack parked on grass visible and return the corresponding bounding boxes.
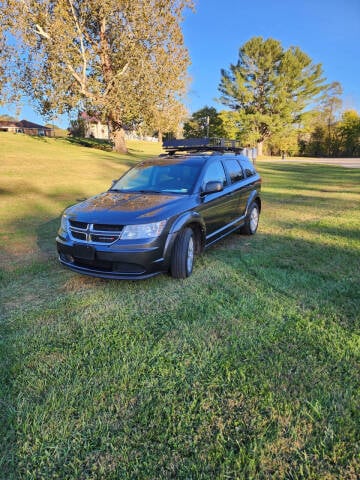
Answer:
[56,139,261,280]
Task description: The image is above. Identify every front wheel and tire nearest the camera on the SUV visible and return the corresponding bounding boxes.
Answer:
[171,228,195,278]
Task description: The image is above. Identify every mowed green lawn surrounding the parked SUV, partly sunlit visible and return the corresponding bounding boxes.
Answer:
[0,133,360,480]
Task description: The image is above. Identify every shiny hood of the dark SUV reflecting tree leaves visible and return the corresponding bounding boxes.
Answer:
[65,192,193,224]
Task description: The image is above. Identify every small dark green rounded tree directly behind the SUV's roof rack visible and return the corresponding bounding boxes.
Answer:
[184,106,225,138]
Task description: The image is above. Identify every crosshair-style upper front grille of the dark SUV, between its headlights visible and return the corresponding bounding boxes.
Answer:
[69,220,123,245]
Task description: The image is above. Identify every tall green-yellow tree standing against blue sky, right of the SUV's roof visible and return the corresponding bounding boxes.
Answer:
[219,37,325,155]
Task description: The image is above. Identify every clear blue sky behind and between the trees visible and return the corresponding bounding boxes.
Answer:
[0,0,360,126]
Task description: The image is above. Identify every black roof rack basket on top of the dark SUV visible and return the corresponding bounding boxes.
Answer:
[163,138,244,155]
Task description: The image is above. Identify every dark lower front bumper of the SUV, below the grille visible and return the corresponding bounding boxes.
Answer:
[56,237,169,280]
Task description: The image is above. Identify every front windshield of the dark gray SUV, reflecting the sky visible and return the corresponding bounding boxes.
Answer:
[111,160,201,194]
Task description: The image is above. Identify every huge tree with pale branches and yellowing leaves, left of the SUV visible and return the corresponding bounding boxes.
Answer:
[0,0,192,151]
